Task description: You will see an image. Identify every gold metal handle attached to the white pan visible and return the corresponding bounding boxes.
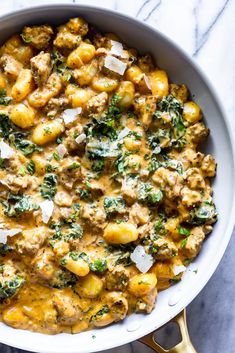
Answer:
[139,309,197,353]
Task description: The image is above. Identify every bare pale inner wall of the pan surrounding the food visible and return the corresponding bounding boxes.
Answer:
[0,5,234,353]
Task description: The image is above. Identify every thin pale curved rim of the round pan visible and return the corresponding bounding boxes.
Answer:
[0,2,235,353]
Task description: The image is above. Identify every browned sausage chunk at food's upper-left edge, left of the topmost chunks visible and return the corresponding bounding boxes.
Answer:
[22,25,53,50]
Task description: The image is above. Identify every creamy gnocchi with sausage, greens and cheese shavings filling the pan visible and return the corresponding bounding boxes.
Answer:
[0,18,217,333]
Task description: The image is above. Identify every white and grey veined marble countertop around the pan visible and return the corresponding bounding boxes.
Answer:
[0,0,235,353]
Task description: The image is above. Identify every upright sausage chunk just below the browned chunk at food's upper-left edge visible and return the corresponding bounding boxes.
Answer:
[30,51,52,86]
